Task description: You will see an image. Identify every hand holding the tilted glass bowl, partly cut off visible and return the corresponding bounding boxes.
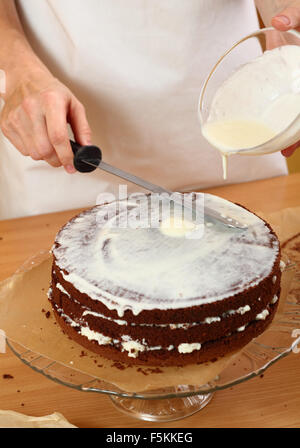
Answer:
[271,1,300,157]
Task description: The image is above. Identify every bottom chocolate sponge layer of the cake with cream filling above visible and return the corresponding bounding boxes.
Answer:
[48,288,278,366]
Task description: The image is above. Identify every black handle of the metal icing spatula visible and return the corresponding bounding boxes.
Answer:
[70,140,102,173]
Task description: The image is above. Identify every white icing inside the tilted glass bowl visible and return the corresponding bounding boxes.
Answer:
[202,45,300,154]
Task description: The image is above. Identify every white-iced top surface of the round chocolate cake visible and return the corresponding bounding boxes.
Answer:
[52,194,279,316]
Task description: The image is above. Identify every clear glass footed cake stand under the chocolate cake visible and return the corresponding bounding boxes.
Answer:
[7,256,300,422]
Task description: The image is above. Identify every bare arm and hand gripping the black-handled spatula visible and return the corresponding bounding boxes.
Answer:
[0,0,91,173]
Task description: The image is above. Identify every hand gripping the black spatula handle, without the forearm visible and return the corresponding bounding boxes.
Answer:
[0,70,91,173]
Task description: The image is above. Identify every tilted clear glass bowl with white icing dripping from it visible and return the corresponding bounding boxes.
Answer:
[198,28,300,179]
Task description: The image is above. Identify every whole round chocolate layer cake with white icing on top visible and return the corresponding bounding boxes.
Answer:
[48,194,281,366]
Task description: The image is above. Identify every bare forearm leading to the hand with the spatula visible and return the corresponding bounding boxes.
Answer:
[0,0,47,99]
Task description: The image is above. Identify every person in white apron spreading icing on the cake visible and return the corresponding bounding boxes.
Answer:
[0,0,300,219]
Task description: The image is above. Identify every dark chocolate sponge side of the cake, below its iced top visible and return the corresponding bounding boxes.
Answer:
[49,200,281,366]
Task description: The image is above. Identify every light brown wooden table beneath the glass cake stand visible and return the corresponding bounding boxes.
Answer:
[0,173,300,428]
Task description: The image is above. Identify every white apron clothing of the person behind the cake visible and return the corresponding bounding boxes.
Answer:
[0,0,287,219]
